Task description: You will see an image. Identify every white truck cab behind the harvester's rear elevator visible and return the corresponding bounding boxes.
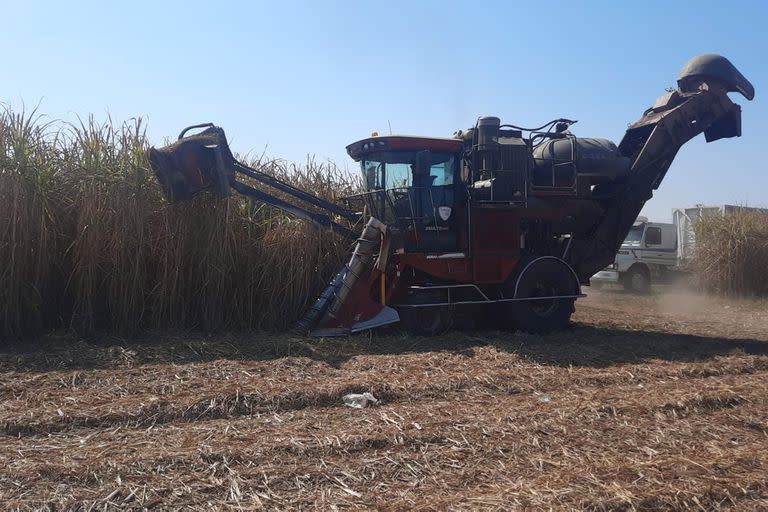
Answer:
[590,217,678,293]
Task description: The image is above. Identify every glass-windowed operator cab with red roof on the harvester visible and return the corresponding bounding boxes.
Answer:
[347,136,466,252]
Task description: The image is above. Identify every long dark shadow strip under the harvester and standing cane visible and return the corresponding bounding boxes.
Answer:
[0,323,768,372]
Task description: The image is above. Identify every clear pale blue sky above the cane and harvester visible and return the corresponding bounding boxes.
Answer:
[0,0,768,221]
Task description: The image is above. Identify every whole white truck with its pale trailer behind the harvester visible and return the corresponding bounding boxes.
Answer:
[590,204,768,293]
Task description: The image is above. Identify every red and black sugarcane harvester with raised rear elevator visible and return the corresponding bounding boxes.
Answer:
[150,54,754,336]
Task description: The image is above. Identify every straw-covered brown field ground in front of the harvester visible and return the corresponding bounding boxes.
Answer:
[0,290,768,510]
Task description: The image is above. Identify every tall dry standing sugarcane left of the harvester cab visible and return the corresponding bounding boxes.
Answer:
[0,111,352,338]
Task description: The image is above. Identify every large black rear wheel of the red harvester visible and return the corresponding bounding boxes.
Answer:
[507,258,578,334]
